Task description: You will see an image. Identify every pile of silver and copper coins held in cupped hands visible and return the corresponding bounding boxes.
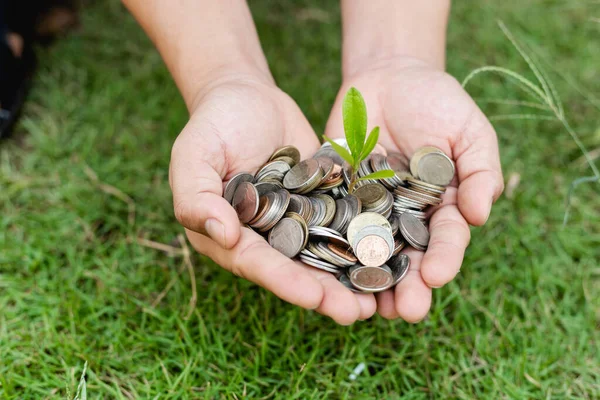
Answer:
[223,139,455,293]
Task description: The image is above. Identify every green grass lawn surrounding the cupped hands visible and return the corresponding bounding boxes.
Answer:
[0,0,600,399]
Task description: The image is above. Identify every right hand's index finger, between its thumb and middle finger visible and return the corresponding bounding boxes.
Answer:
[421,187,471,288]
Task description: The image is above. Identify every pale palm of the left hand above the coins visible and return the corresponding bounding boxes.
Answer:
[176,82,319,180]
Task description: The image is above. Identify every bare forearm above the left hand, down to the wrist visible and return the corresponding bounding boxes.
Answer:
[123,0,273,110]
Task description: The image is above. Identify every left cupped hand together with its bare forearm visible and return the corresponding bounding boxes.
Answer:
[124,0,377,325]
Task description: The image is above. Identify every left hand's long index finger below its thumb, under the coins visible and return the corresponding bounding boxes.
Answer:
[186,228,326,310]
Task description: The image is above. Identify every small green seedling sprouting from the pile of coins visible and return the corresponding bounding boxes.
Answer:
[323,87,395,193]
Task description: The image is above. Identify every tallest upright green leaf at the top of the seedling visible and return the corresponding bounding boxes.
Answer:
[342,87,367,160]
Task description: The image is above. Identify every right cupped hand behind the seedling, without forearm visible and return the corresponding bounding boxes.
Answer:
[326,58,504,322]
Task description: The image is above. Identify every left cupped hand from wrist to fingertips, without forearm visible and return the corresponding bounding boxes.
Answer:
[169,75,376,325]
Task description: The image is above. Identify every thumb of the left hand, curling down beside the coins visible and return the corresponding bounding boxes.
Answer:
[169,124,240,248]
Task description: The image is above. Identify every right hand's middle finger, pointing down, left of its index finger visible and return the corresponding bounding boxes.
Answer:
[395,249,431,324]
